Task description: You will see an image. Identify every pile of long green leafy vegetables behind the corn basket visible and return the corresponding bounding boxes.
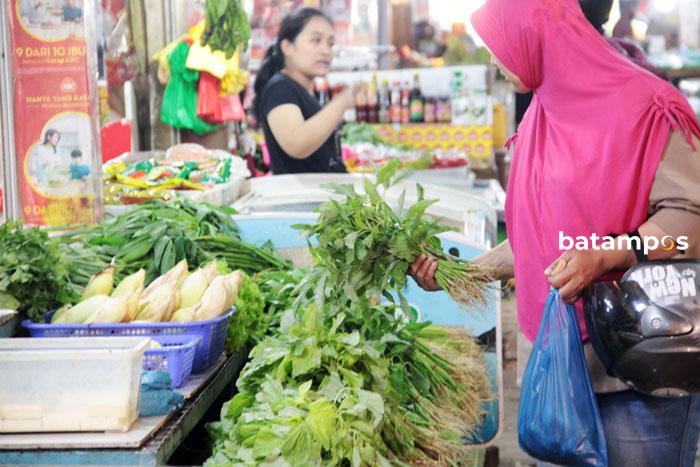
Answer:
[54,198,290,293]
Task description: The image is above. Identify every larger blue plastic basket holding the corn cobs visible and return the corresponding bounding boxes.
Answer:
[22,308,236,373]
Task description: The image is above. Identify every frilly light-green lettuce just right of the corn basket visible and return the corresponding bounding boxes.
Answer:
[226,275,267,353]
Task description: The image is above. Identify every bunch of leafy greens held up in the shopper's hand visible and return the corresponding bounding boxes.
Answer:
[295,161,493,311]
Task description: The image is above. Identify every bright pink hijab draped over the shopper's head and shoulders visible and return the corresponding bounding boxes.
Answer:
[471,0,700,341]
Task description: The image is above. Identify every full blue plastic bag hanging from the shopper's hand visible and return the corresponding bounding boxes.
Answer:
[518,289,608,466]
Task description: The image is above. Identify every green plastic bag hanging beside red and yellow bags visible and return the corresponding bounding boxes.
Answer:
[160,41,219,135]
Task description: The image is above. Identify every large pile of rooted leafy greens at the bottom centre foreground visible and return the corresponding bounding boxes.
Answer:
[206,305,490,466]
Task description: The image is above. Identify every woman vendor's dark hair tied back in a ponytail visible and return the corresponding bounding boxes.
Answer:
[253,7,333,120]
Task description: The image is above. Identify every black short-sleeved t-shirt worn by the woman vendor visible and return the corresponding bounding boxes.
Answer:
[260,73,347,175]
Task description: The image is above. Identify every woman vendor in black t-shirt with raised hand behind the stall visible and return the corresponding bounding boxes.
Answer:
[254,8,363,175]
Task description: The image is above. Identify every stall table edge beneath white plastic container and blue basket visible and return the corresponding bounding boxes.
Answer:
[0,351,247,465]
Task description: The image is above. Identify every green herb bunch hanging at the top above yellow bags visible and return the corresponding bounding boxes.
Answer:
[202,0,251,58]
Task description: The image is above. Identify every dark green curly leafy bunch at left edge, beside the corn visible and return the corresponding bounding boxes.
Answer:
[0,222,72,321]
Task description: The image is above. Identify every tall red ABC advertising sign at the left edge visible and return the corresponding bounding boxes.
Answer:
[9,0,99,225]
